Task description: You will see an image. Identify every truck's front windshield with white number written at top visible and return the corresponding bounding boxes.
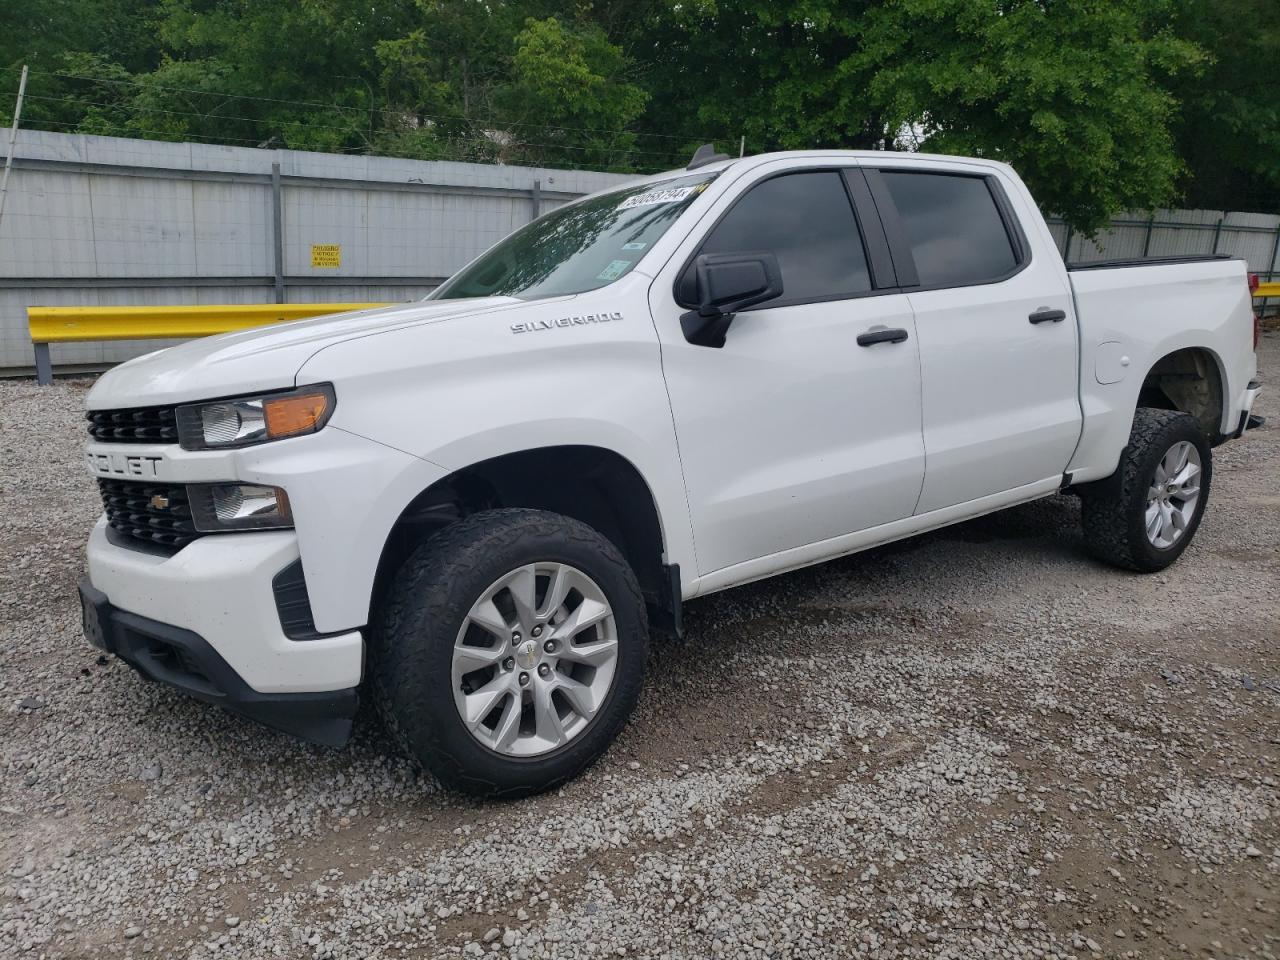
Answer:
[431,173,716,300]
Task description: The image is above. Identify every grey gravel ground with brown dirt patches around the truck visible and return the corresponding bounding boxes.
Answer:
[0,332,1280,960]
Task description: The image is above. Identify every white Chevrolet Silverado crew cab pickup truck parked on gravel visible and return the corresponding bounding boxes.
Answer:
[82,147,1258,796]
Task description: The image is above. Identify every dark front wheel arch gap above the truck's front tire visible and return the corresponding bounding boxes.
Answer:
[370,444,681,632]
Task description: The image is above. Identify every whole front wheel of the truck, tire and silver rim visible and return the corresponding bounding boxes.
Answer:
[370,509,648,796]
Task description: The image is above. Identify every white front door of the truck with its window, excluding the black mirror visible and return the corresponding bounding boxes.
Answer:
[650,161,924,575]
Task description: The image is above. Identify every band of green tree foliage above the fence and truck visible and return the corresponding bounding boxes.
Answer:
[0,0,1280,230]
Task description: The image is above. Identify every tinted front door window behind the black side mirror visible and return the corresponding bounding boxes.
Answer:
[696,170,872,306]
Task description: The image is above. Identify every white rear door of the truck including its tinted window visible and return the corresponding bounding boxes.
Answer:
[867,161,1080,513]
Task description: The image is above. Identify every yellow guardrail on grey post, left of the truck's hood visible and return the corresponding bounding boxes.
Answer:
[27,303,389,384]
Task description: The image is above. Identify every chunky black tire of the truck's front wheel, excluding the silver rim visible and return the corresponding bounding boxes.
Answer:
[369,508,649,797]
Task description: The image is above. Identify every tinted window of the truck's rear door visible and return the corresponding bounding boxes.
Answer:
[882,170,1018,287]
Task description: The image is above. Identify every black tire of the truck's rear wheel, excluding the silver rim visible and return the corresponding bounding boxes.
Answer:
[1080,407,1213,573]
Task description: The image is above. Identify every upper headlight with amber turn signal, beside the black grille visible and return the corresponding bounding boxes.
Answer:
[178,384,335,451]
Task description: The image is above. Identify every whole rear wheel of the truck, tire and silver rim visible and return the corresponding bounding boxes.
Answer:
[1080,407,1213,573]
